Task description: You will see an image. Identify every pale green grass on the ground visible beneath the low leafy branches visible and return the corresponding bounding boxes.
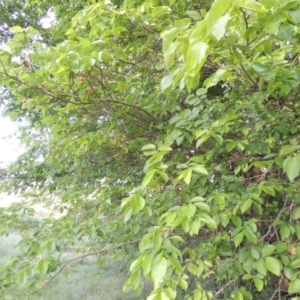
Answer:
[0,233,150,300]
